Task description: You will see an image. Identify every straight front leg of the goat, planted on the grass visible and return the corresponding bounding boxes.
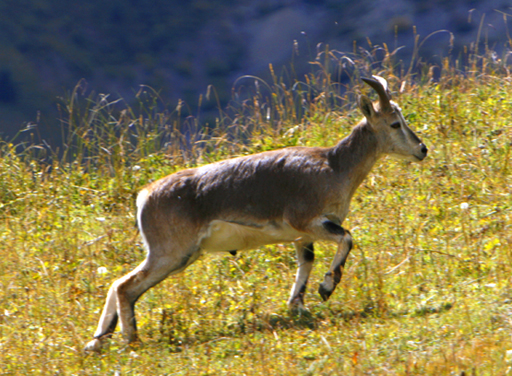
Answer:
[288,242,315,310]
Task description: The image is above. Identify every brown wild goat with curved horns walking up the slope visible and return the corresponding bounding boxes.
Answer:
[86,76,427,351]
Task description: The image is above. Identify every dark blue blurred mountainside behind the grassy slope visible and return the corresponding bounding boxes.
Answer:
[0,0,512,142]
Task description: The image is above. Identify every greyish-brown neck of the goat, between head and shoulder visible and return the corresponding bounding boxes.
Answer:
[329,120,381,197]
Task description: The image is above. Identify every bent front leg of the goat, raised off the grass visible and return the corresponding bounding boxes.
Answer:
[318,222,352,301]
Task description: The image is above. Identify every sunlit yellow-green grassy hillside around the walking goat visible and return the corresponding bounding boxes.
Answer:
[0,47,512,375]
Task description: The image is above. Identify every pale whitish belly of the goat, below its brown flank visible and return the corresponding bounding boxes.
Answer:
[199,220,304,252]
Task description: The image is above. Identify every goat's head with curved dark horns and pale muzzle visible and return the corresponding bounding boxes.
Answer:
[359,76,428,162]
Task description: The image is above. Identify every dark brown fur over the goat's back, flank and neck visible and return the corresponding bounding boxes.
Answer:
[143,123,377,231]
